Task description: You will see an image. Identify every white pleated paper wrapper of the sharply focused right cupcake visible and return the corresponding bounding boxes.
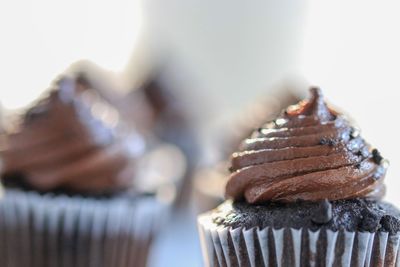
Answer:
[198,215,400,267]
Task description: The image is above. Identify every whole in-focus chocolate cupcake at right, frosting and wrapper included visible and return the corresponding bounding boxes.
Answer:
[198,88,400,266]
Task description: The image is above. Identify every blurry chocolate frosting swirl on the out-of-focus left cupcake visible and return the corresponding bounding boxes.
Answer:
[0,75,143,193]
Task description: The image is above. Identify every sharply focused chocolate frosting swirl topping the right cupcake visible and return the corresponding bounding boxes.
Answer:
[226,88,387,203]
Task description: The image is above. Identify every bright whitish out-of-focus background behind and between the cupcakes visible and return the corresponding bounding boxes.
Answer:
[0,0,400,266]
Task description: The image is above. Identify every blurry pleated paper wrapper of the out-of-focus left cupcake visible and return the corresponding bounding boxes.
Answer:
[0,190,166,267]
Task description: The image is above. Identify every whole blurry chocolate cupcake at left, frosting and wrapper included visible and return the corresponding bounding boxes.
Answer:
[0,74,167,266]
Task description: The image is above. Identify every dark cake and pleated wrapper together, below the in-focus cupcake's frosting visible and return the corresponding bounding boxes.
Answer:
[198,199,400,267]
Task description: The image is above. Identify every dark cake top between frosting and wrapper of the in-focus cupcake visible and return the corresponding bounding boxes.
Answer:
[210,199,400,233]
